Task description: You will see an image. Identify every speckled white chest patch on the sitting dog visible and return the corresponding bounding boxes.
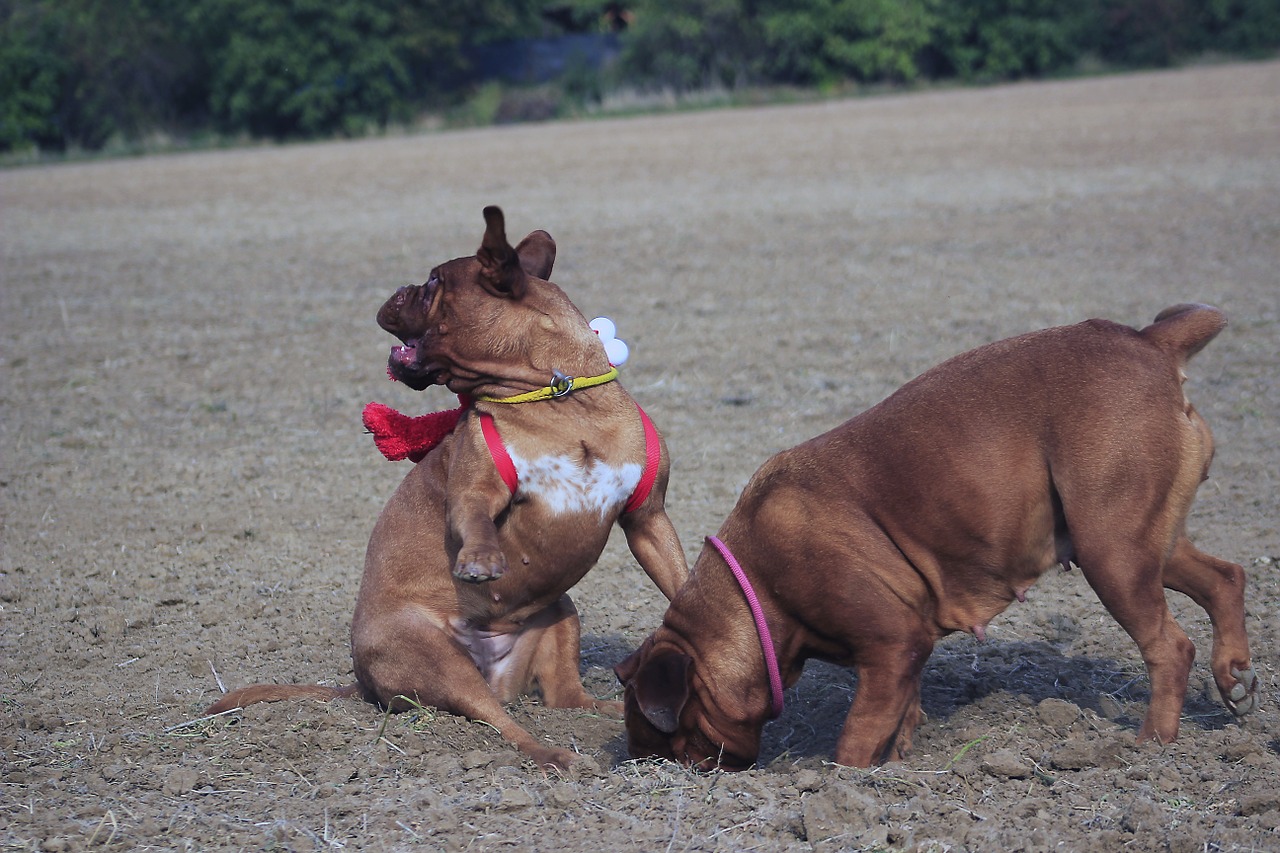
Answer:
[508,447,641,516]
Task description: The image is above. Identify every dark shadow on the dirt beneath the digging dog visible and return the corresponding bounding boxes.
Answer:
[582,627,1235,767]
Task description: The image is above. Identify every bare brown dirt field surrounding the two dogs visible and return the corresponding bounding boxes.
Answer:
[0,63,1280,853]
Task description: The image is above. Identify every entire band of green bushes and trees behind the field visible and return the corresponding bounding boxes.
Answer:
[0,0,1280,151]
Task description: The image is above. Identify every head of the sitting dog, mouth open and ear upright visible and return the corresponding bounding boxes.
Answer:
[378,206,608,393]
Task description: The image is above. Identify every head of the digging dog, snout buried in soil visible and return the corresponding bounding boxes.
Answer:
[614,629,763,771]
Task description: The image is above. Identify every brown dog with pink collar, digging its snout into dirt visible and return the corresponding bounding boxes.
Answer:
[617,305,1257,770]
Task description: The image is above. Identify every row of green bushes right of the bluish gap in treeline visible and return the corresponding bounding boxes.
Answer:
[622,0,1280,90]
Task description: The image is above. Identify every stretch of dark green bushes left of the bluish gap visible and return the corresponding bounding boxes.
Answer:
[0,0,538,150]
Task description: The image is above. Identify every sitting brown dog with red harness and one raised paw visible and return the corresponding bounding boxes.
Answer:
[209,207,687,767]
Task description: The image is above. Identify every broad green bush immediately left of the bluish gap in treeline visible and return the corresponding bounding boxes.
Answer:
[188,0,541,138]
